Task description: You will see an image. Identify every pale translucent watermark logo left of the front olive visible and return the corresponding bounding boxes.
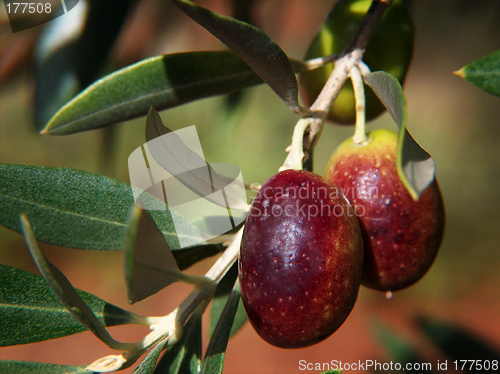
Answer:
[128,126,248,248]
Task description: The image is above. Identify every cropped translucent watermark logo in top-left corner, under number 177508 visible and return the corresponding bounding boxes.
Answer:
[4,0,80,32]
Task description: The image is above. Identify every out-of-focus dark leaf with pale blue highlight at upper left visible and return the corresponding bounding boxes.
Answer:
[35,0,133,130]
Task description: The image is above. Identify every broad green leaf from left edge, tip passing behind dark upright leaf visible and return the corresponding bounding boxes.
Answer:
[0,164,207,250]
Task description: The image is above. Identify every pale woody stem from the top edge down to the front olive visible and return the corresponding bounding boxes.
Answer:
[280,0,392,170]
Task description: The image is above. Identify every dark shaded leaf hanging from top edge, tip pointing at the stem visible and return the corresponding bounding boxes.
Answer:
[173,0,300,112]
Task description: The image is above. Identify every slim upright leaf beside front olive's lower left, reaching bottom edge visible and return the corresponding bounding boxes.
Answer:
[201,281,241,374]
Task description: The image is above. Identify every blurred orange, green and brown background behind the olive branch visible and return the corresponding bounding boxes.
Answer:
[0,0,500,373]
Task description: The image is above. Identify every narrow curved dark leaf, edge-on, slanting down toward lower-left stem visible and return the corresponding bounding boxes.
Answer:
[21,214,131,350]
